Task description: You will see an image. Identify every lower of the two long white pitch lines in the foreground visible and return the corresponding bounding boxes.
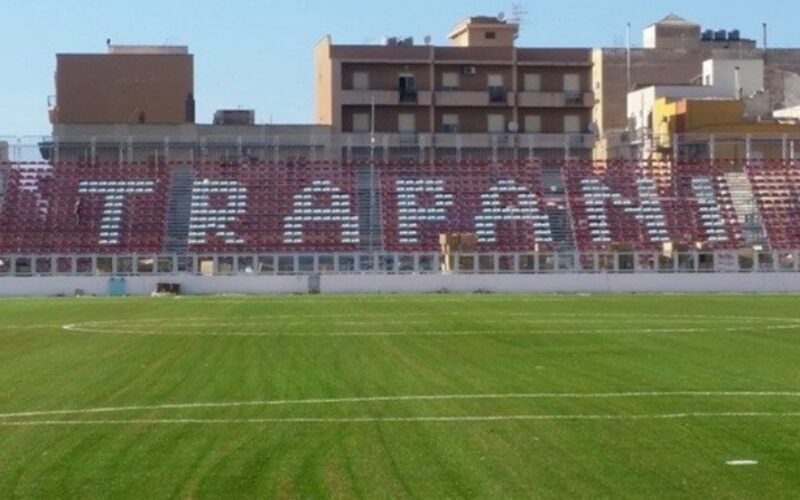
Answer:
[0,412,800,427]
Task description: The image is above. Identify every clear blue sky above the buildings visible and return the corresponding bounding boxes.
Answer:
[0,0,800,136]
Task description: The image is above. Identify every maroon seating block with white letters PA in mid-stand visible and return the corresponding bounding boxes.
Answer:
[380,162,552,251]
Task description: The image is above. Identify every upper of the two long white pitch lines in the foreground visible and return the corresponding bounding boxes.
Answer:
[0,391,800,420]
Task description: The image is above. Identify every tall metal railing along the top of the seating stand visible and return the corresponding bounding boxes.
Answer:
[0,130,800,163]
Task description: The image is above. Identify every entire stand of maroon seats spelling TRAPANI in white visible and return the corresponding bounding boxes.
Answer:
[0,161,800,254]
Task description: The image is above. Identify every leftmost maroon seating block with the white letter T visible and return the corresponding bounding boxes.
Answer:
[0,164,169,253]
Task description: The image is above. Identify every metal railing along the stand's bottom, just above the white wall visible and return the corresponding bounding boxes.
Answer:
[0,251,800,278]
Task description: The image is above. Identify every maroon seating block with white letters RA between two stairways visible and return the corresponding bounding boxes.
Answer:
[189,163,358,252]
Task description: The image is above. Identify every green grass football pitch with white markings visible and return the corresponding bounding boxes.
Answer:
[0,295,800,499]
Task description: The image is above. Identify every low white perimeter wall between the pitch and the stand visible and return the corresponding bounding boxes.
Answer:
[0,273,800,297]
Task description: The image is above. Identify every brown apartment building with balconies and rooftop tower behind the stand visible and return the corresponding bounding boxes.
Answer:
[315,17,594,134]
